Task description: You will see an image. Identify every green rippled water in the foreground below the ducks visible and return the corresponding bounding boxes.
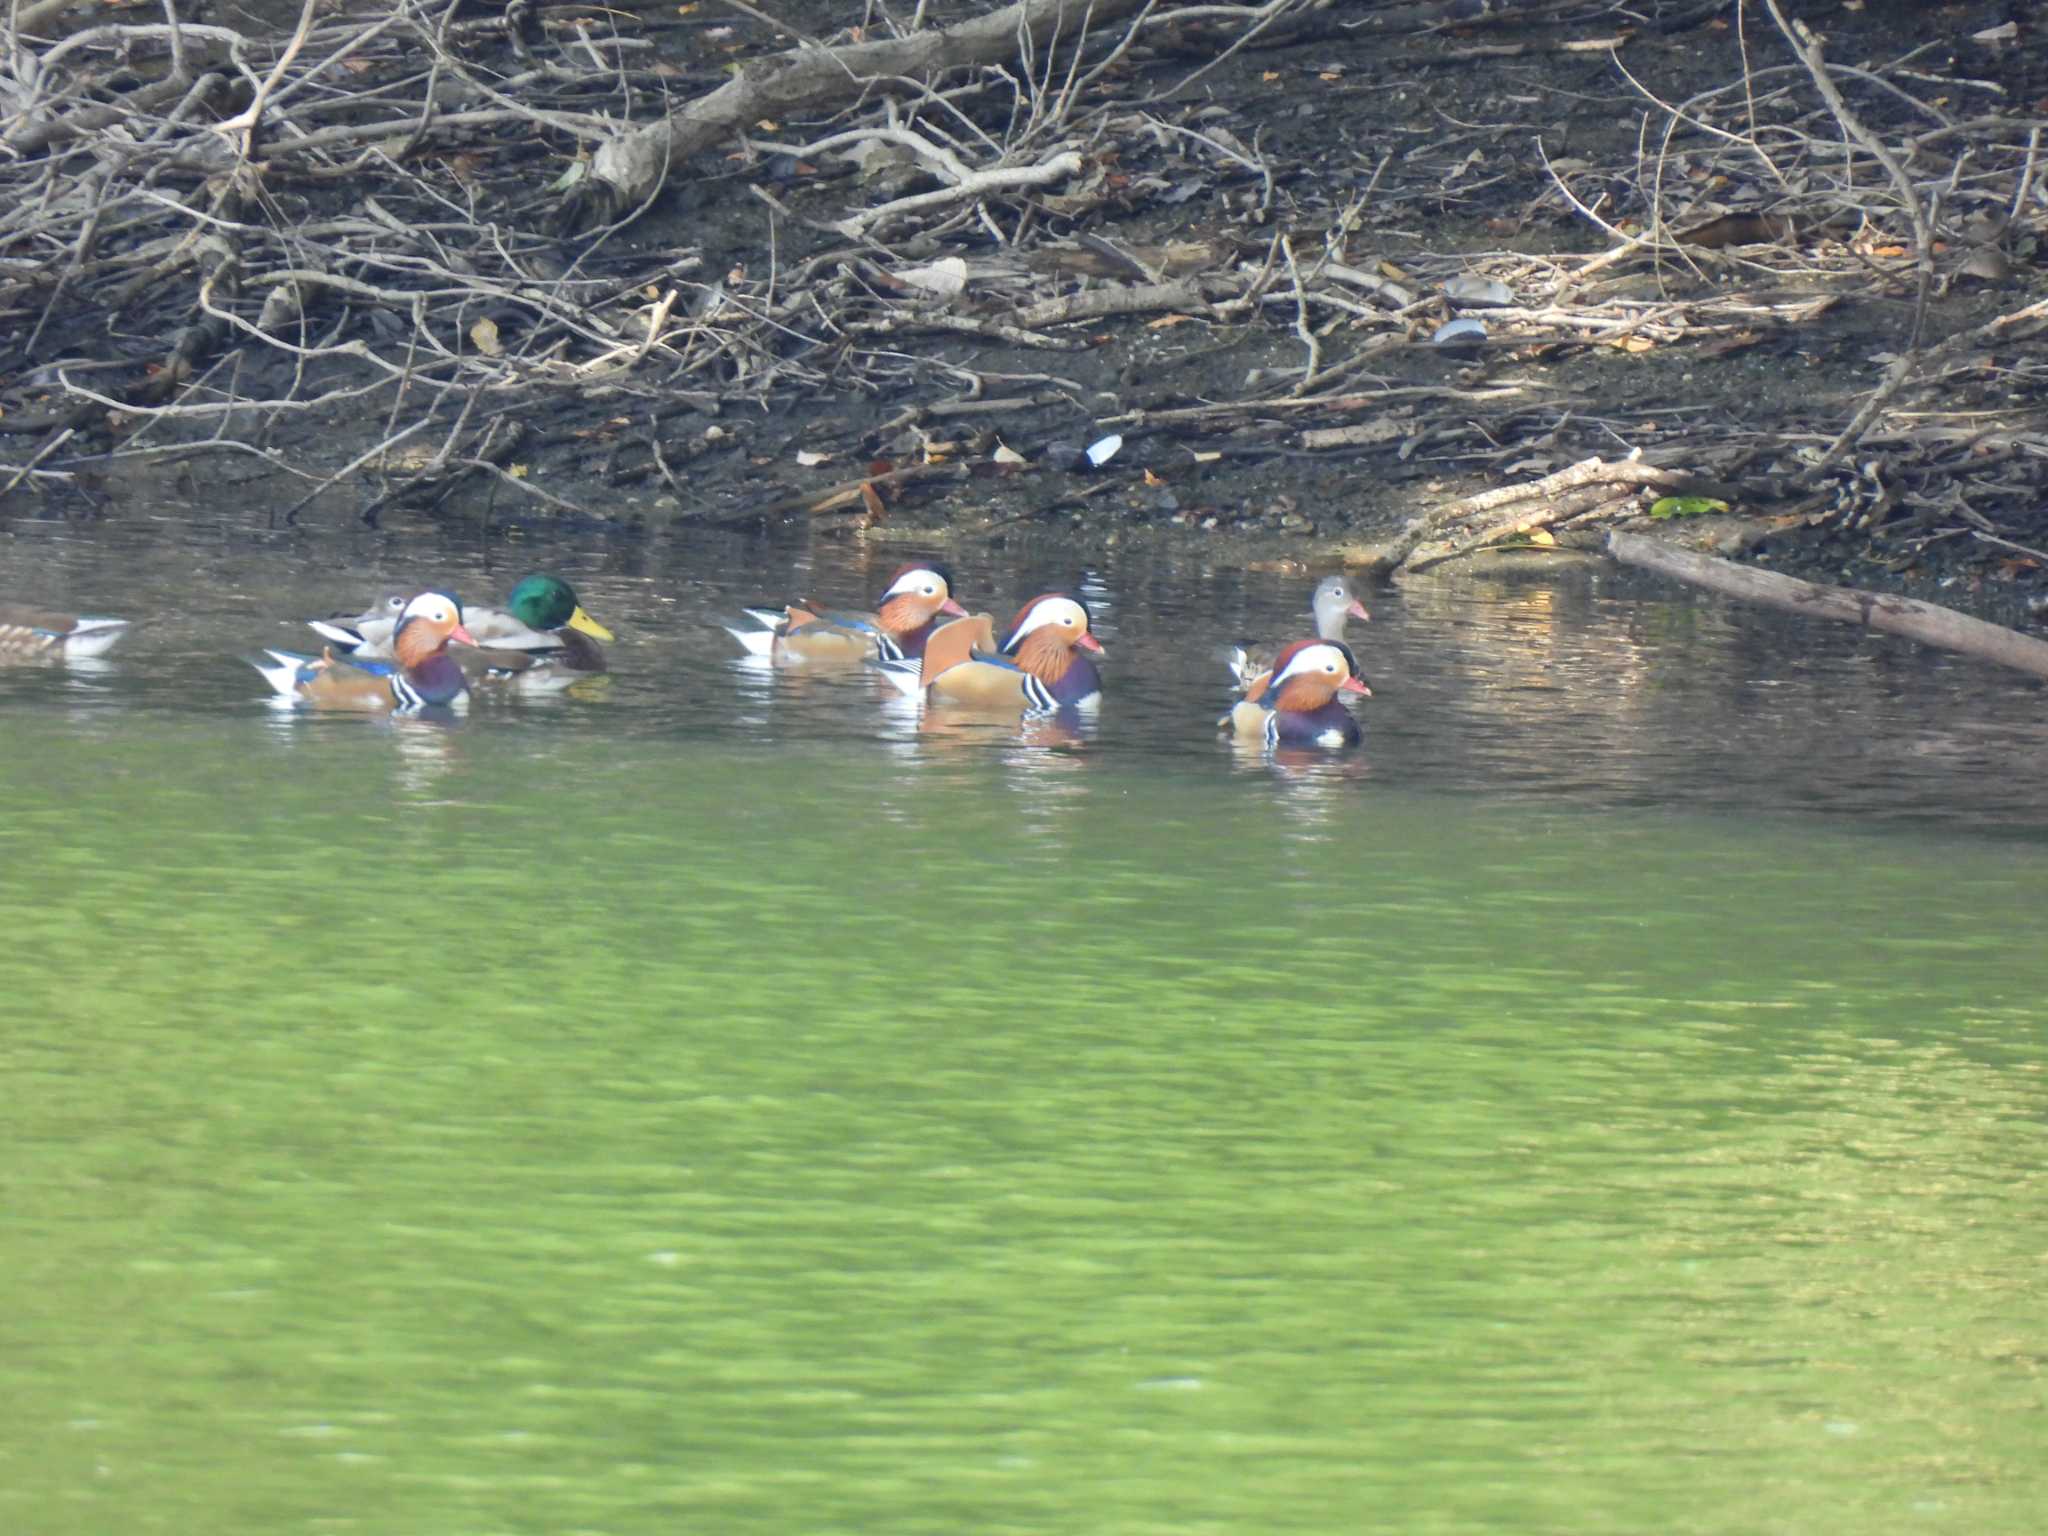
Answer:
[0,712,2048,1536]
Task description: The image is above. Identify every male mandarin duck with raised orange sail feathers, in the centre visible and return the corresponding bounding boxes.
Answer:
[881,592,1102,715]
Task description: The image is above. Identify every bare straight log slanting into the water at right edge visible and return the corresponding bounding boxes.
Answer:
[1608,532,2048,678]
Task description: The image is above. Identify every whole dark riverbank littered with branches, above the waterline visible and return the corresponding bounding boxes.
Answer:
[0,4,2048,623]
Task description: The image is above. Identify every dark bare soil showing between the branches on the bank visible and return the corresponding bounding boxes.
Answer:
[0,0,2048,621]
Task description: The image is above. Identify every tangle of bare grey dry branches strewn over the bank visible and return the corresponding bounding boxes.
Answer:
[0,0,2048,561]
